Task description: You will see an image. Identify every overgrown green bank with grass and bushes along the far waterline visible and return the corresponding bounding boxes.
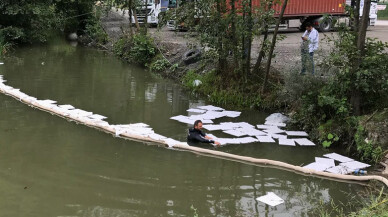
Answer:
[110,29,388,164]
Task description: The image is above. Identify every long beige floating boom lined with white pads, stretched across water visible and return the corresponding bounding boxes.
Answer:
[0,75,388,186]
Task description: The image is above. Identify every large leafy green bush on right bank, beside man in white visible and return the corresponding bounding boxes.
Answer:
[295,20,388,163]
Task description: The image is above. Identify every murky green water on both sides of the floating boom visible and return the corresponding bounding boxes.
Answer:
[0,42,363,217]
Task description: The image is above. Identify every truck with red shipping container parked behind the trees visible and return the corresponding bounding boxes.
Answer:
[167,0,377,32]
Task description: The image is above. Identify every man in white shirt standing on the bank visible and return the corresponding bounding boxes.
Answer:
[301,23,319,74]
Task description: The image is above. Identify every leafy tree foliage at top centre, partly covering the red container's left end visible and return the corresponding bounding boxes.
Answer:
[163,0,277,76]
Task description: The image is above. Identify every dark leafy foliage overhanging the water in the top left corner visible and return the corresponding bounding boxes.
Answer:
[0,0,103,44]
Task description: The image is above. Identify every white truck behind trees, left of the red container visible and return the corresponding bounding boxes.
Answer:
[131,0,169,26]
